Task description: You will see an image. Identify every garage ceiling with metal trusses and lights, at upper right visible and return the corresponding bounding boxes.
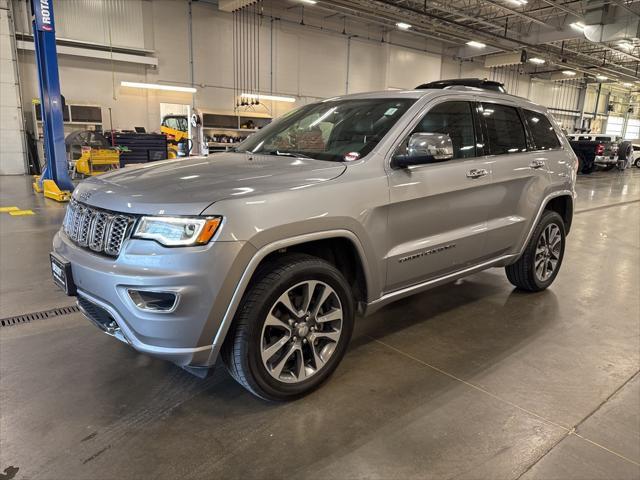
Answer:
[298,0,640,82]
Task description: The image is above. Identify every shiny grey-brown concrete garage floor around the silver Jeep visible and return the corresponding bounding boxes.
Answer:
[0,169,640,480]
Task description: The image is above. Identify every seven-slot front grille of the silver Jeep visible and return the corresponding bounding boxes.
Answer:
[62,200,134,257]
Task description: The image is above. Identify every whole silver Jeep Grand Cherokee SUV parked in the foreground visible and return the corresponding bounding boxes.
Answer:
[51,87,577,400]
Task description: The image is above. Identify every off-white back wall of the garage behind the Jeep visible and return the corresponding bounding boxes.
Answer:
[14,0,592,172]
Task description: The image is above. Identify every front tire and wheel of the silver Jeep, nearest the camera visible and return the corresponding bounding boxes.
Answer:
[222,254,355,401]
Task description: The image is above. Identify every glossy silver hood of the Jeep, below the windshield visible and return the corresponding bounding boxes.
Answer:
[73,153,346,215]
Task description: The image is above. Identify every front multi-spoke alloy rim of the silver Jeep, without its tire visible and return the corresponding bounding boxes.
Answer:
[260,280,343,383]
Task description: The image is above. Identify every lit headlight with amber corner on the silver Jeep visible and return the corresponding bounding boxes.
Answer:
[133,217,222,247]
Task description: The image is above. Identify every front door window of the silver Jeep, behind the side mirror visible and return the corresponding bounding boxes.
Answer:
[413,102,476,158]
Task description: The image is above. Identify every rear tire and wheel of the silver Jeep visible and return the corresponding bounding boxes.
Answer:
[505,210,566,292]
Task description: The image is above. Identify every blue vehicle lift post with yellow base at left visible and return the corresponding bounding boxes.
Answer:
[30,0,74,202]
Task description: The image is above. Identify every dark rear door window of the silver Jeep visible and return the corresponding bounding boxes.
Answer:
[482,103,527,155]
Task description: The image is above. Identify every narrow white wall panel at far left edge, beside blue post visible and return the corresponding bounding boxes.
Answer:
[0,0,25,175]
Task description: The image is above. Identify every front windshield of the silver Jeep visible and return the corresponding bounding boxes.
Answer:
[235,98,415,162]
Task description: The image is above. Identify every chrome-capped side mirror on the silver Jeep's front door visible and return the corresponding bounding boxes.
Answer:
[391,132,453,168]
